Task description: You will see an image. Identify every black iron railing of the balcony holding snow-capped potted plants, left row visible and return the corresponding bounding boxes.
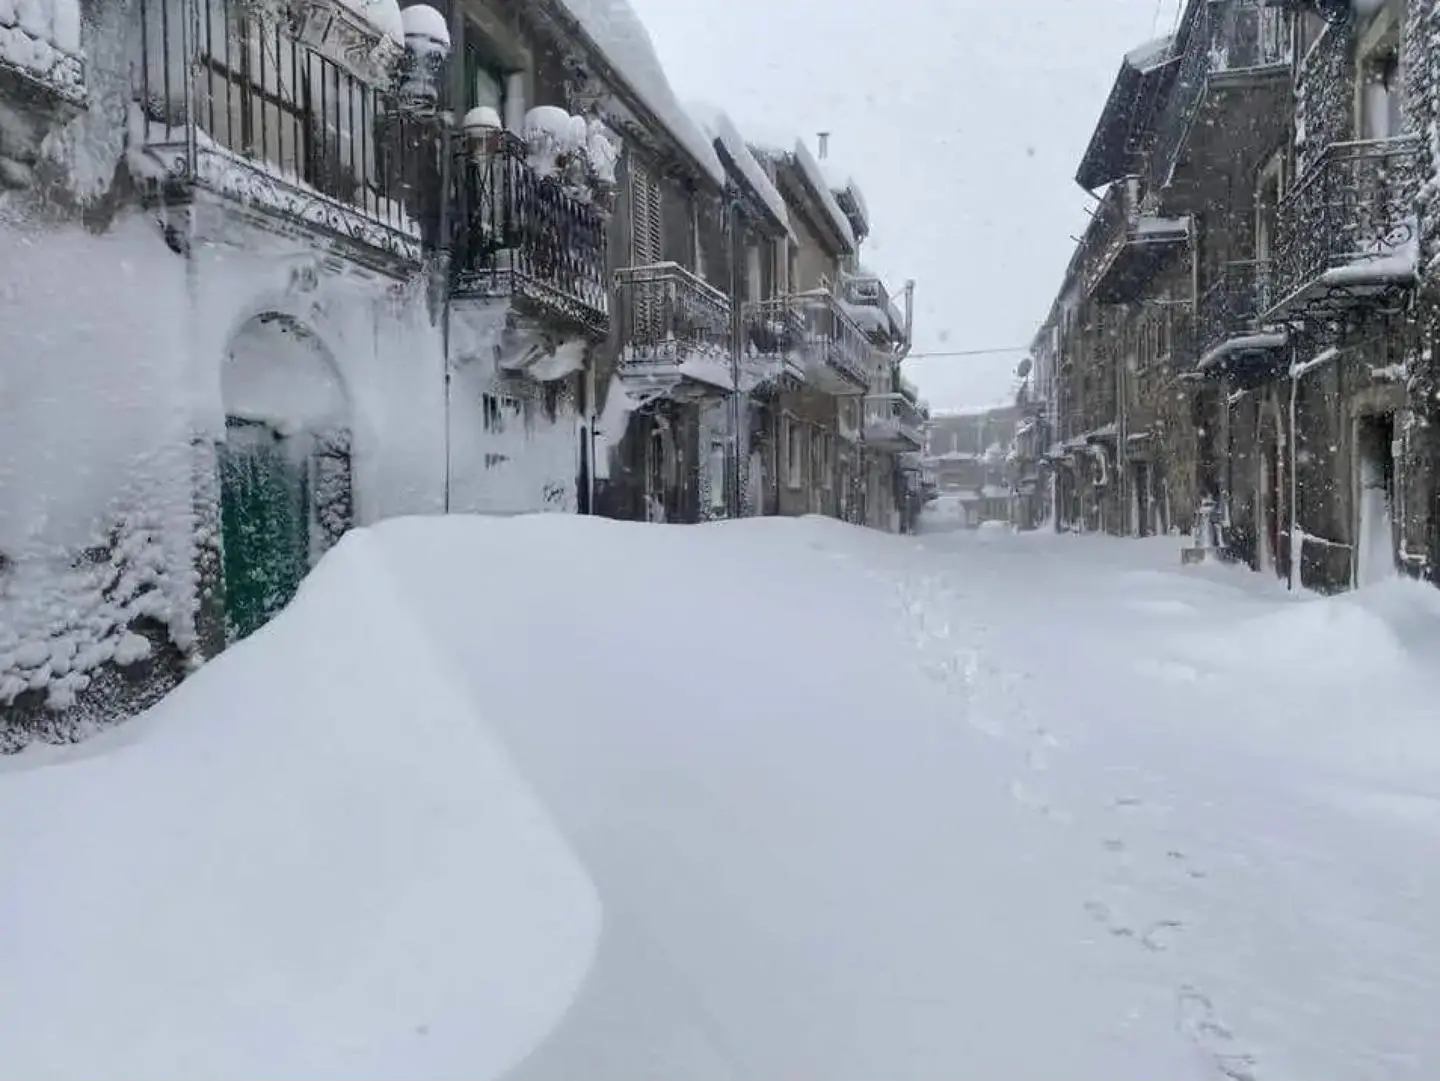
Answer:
[452,132,609,328]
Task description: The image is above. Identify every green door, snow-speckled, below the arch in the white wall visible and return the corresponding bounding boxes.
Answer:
[220,419,311,642]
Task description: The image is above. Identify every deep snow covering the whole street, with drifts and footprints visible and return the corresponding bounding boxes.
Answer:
[0,517,1440,1081]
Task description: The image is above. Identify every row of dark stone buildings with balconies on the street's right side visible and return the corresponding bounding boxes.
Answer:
[1037,0,1440,590]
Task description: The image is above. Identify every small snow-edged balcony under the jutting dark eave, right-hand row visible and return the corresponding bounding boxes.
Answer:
[1086,177,1189,304]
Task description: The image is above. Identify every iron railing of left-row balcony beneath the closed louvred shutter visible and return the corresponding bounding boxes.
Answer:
[615,263,730,363]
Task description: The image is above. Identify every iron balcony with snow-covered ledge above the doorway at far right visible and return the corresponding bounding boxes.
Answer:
[1266,135,1420,321]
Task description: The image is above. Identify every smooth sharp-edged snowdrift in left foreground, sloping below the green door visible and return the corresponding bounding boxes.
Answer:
[0,533,600,1081]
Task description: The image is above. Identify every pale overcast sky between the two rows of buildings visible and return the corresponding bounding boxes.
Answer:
[631,0,1176,407]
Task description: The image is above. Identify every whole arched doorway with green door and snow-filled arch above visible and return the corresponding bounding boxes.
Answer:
[217,314,353,642]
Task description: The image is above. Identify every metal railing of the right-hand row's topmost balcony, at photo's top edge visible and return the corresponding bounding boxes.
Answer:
[1151,0,1292,189]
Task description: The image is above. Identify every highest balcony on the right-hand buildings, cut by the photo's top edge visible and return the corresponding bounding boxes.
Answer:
[1149,0,1293,212]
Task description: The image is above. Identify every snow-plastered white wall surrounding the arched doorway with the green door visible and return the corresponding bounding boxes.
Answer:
[0,213,452,708]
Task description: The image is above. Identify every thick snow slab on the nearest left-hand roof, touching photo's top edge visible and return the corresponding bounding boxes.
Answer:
[556,0,726,187]
